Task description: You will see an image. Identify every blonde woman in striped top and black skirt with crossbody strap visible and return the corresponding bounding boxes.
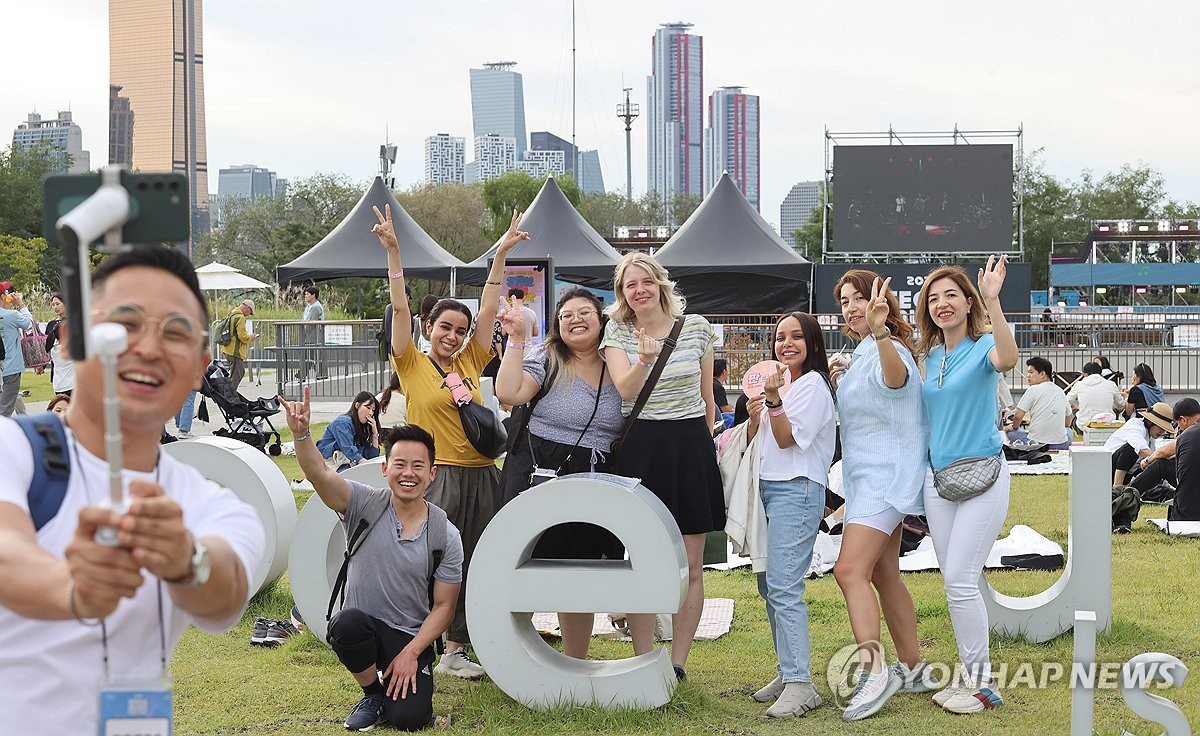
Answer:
[600,251,725,680]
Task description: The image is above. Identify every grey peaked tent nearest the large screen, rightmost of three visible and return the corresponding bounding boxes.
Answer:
[654,173,812,315]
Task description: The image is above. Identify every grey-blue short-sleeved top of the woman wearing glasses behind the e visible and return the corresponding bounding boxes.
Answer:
[521,346,625,451]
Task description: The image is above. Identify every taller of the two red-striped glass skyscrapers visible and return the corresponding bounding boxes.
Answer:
[646,23,704,206]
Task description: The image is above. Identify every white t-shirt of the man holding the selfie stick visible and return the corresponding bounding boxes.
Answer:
[0,419,265,734]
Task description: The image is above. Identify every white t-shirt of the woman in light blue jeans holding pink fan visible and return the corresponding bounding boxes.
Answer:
[758,371,836,486]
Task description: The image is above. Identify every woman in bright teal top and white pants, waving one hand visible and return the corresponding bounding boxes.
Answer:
[917,256,1018,713]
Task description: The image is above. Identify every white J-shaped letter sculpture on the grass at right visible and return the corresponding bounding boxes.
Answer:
[983,448,1112,644]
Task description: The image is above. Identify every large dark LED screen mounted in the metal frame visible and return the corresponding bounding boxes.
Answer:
[830,144,1014,253]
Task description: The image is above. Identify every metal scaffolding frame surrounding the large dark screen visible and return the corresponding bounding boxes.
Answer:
[821,124,1025,263]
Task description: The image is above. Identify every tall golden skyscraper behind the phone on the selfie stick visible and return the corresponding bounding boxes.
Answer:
[108,0,209,255]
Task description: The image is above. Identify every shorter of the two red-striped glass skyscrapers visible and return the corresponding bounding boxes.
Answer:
[704,86,762,211]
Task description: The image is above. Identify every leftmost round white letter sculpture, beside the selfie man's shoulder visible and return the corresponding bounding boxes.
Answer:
[162,437,296,593]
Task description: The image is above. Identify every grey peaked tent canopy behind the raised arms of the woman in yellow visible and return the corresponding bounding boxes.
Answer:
[276,176,463,286]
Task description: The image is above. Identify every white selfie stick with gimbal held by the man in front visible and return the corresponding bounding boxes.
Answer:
[55,166,130,546]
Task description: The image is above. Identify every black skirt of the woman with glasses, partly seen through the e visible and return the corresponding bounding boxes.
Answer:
[500,430,625,560]
